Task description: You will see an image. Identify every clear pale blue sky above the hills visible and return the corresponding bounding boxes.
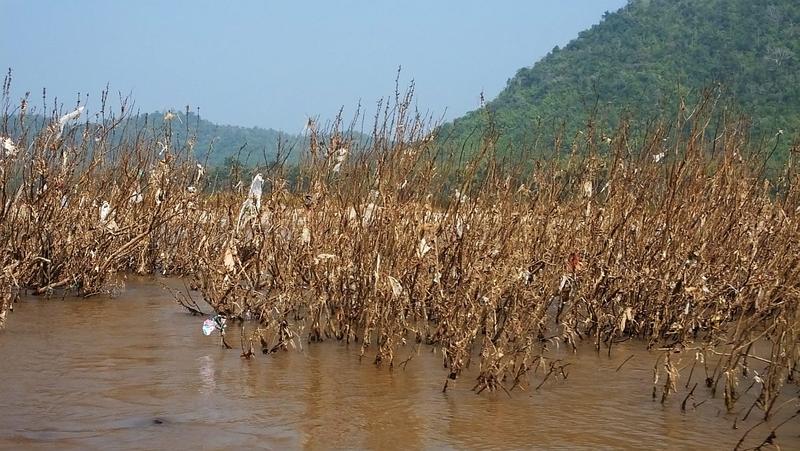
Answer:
[0,0,626,132]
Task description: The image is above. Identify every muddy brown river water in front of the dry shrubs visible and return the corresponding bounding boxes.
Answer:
[0,280,800,450]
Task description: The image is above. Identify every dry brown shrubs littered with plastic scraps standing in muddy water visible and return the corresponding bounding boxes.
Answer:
[0,78,800,446]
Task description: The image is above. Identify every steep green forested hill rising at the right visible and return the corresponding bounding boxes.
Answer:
[443,0,800,154]
